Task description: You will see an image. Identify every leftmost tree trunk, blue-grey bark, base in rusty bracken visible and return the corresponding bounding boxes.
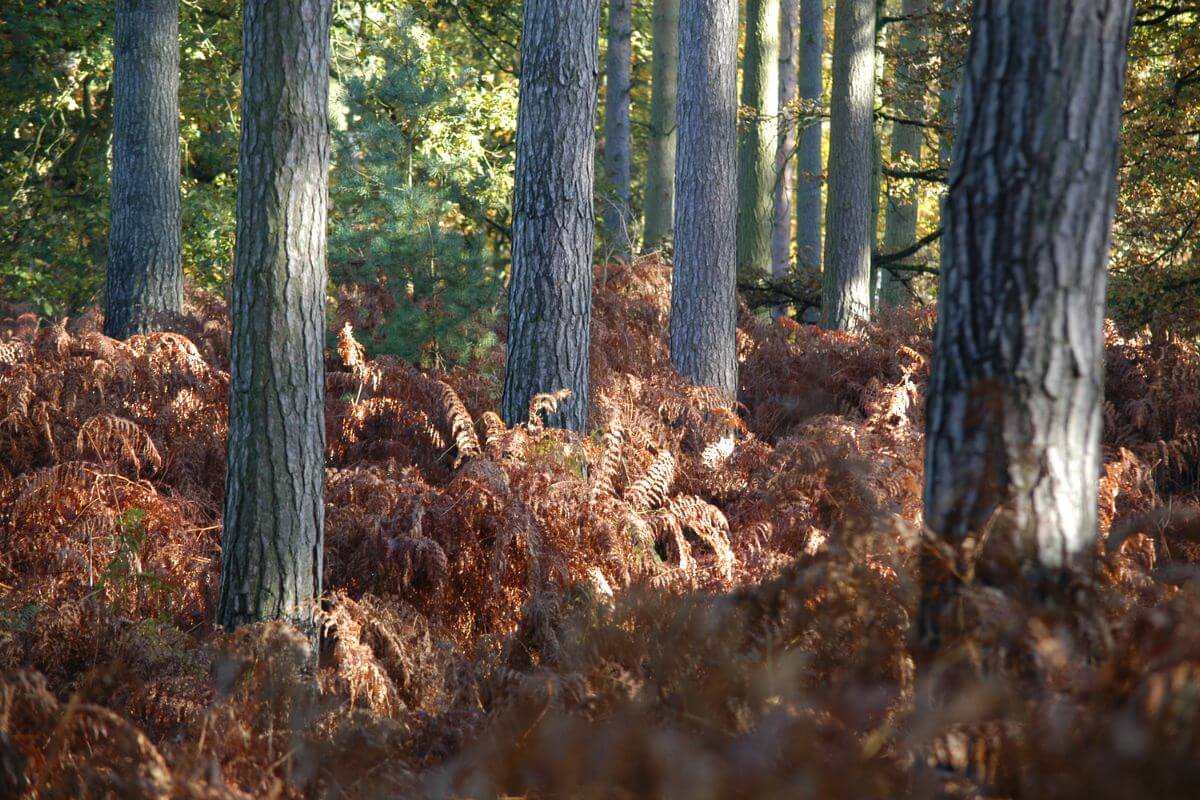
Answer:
[104,0,184,339]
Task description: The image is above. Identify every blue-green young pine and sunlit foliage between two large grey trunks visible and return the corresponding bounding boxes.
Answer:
[330,11,516,361]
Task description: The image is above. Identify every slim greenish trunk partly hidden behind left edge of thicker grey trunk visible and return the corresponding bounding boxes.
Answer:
[642,0,679,252]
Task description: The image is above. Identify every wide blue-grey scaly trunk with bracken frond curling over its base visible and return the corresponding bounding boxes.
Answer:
[503,0,600,431]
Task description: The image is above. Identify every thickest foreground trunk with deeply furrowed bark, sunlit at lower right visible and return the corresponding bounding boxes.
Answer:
[925,0,1133,575]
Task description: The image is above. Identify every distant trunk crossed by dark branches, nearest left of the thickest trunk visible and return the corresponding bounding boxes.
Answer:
[880,0,929,307]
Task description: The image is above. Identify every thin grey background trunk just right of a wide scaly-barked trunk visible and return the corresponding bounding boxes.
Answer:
[604,0,634,259]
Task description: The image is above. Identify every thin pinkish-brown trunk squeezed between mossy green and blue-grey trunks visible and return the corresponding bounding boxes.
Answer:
[770,0,800,291]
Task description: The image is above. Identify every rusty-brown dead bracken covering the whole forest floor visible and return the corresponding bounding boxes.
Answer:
[0,259,1200,800]
